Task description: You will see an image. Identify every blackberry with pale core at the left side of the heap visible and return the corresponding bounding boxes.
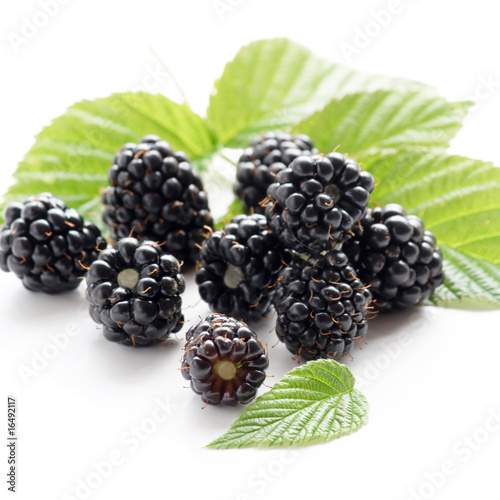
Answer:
[196,214,286,322]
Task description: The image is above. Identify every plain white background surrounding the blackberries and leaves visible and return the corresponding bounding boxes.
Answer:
[0,0,500,500]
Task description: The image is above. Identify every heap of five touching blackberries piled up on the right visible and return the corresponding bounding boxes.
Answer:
[197,129,443,361]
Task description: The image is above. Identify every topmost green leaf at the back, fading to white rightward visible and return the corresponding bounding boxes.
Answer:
[207,38,430,147]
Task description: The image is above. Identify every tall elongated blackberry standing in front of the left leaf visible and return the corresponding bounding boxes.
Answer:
[102,135,213,263]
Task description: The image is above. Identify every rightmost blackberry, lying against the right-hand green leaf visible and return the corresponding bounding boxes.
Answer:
[344,203,444,312]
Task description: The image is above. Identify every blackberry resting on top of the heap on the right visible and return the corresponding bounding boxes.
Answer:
[266,153,374,254]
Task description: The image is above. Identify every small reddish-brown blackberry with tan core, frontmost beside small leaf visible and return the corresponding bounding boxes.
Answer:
[181,314,269,406]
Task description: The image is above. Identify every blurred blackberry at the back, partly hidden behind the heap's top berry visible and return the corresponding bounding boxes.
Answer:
[234,132,318,214]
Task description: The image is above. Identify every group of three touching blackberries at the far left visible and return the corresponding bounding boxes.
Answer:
[0,136,212,346]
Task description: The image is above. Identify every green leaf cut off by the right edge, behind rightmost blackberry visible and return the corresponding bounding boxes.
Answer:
[361,149,500,307]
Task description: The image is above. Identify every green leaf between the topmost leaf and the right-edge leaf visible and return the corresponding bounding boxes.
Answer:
[293,89,472,157]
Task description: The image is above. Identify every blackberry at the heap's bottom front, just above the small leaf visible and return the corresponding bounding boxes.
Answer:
[273,250,372,361]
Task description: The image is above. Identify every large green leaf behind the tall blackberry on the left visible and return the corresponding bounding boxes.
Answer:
[2,92,216,222]
